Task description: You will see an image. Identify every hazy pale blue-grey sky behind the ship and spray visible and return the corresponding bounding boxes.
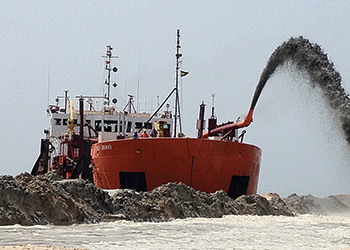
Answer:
[0,0,350,197]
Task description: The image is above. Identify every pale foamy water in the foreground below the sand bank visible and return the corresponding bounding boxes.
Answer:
[0,215,350,250]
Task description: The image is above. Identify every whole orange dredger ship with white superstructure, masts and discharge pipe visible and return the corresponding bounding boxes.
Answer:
[31,30,261,198]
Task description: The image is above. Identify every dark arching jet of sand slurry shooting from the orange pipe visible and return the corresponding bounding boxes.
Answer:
[251,37,350,143]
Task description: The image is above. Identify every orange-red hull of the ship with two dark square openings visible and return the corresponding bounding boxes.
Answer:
[91,138,261,198]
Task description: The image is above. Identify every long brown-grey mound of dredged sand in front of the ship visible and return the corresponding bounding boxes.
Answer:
[0,173,350,225]
